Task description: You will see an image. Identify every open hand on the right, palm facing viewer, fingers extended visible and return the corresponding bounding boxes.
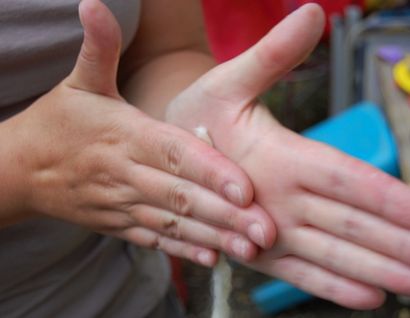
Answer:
[167,4,410,309]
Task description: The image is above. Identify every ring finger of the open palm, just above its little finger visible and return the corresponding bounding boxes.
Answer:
[284,228,410,294]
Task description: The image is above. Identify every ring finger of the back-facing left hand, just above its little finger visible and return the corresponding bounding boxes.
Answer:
[126,205,257,260]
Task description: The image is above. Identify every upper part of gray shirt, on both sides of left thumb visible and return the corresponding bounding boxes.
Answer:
[0,0,140,107]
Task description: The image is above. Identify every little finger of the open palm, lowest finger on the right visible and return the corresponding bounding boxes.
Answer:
[247,256,385,310]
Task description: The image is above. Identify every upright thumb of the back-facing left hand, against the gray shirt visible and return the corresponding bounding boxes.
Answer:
[67,0,121,98]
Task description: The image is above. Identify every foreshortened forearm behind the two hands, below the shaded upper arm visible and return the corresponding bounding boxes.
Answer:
[122,50,215,119]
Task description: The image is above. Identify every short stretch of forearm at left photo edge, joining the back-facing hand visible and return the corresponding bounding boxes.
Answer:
[0,114,30,228]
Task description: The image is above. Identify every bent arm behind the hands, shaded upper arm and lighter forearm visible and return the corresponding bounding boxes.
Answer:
[121,0,215,119]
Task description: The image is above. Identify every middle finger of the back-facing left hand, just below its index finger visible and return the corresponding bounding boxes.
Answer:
[123,149,276,248]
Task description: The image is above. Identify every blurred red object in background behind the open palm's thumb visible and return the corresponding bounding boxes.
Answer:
[202,0,365,62]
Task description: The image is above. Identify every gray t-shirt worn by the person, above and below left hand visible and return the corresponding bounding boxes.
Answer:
[0,0,169,318]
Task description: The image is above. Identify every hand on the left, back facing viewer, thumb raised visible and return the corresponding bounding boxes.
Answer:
[4,0,275,266]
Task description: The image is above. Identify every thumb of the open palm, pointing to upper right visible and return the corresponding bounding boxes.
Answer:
[199,3,325,107]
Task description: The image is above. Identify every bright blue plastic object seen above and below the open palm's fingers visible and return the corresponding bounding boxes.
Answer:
[251,102,400,314]
